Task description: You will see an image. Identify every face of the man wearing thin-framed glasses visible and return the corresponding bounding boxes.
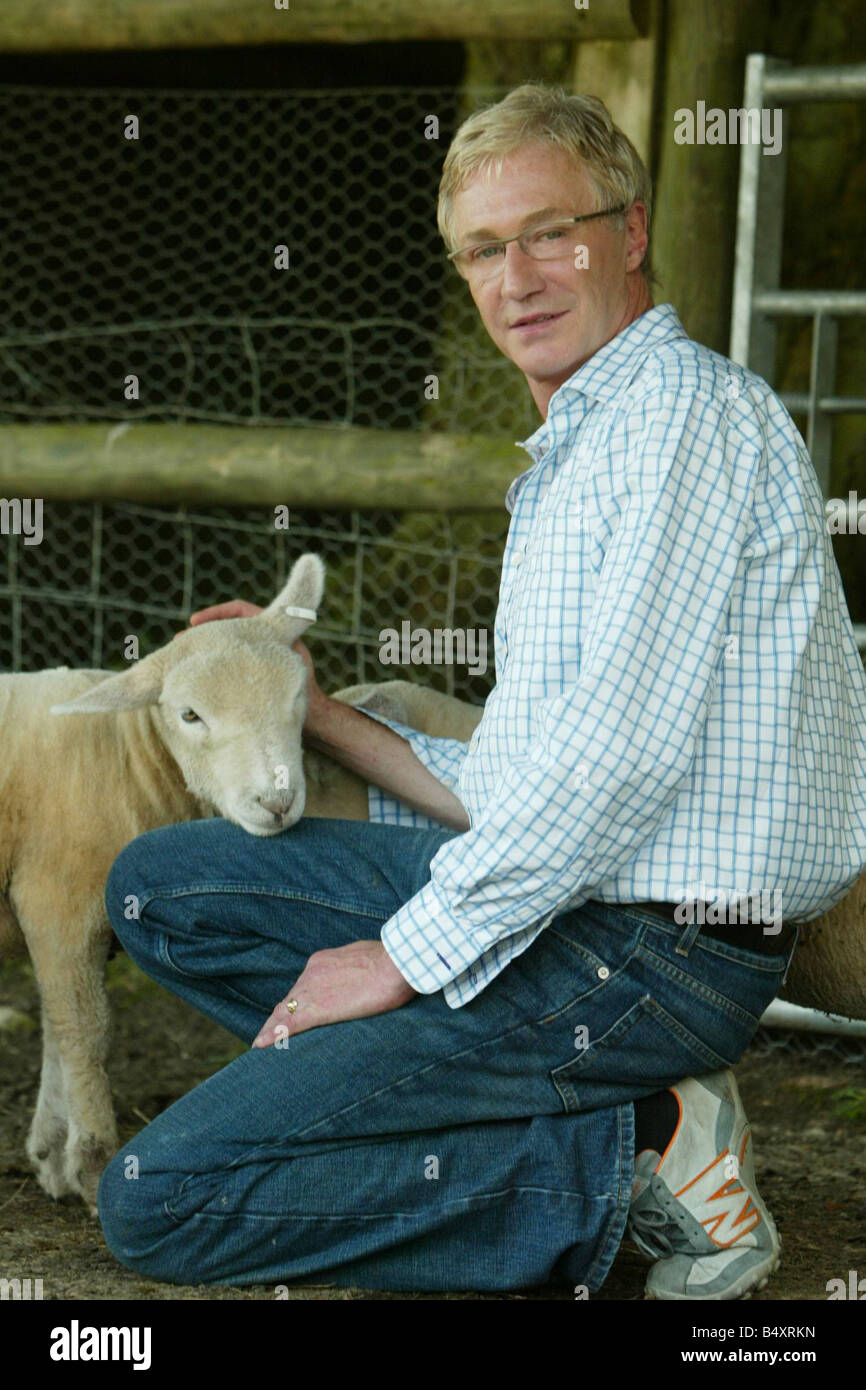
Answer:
[453,143,652,416]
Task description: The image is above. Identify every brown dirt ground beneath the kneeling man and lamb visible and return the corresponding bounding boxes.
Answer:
[0,955,866,1300]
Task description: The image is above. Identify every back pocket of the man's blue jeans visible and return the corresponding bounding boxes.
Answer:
[550,994,751,1112]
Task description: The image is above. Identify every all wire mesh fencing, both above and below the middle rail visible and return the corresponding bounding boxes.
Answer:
[0,86,537,701]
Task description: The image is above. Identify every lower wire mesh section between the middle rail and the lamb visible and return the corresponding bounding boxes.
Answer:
[0,502,507,703]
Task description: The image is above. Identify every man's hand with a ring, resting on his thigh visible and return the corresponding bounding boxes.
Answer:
[253,941,417,1047]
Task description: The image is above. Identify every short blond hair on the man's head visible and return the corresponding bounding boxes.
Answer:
[436,82,655,284]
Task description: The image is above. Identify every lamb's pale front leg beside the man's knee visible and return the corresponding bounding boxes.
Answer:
[29,922,117,1215]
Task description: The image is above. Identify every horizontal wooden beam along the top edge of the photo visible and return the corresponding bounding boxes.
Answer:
[0,0,646,53]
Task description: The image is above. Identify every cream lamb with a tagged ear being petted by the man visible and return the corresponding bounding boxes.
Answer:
[0,555,481,1211]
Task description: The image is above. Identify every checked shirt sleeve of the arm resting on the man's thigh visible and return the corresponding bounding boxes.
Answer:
[382,391,762,1006]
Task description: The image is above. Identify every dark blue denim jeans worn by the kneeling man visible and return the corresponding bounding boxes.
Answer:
[99,819,791,1291]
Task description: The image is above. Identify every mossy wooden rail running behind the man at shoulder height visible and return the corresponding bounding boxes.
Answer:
[0,424,517,512]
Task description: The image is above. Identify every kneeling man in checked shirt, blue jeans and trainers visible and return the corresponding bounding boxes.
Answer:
[100,85,866,1298]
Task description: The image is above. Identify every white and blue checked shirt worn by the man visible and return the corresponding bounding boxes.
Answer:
[361,304,866,1008]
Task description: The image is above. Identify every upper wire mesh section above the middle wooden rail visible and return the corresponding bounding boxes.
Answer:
[0,86,534,432]
